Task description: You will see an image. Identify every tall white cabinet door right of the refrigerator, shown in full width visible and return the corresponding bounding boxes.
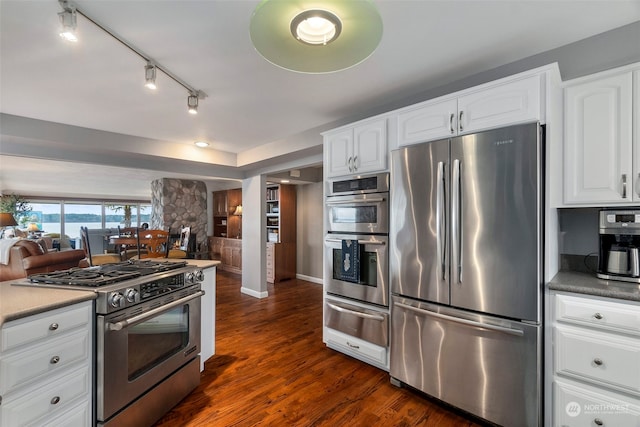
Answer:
[564,72,633,204]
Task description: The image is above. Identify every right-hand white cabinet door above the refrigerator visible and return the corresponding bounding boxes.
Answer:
[458,75,541,133]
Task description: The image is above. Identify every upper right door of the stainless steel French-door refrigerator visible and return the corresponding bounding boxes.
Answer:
[451,123,542,322]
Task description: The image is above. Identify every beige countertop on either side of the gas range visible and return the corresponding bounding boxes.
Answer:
[0,259,220,328]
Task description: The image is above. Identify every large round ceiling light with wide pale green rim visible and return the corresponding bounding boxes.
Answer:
[249,0,382,73]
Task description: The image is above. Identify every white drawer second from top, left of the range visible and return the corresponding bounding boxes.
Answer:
[0,329,91,394]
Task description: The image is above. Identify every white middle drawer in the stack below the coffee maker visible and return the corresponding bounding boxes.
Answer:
[554,326,640,396]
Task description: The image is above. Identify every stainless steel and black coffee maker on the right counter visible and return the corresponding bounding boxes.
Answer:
[597,210,640,283]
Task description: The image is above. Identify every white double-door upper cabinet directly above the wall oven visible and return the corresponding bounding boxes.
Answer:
[324,118,387,177]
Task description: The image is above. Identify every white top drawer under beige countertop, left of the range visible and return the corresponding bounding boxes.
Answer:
[0,302,92,352]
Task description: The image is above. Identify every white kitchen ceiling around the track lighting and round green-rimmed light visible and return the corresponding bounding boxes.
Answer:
[0,0,640,197]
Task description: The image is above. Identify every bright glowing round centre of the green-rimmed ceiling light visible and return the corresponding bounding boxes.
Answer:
[290,9,342,45]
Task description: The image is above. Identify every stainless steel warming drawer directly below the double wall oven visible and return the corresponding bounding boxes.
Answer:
[325,299,389,347]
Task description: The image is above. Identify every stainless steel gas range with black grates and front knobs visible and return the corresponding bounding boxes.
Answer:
[23,260,204,427]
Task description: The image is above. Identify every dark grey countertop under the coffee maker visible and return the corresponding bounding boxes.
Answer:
[547,271,640,302]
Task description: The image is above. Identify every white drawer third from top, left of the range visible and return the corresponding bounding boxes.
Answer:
[0,366,91,426]
